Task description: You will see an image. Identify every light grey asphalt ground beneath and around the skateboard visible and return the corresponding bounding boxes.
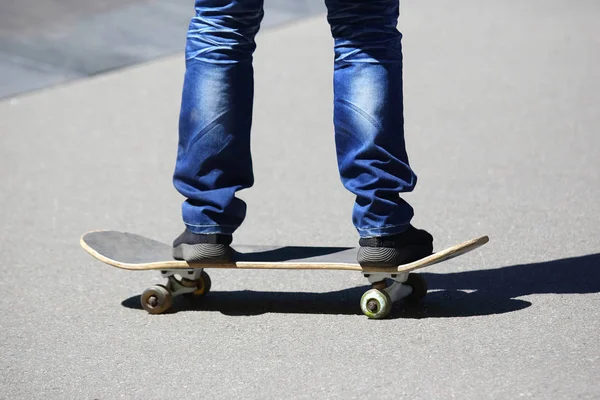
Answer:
[0,0,600,399]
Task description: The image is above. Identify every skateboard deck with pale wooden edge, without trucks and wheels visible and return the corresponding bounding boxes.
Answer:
[81,231,489,273]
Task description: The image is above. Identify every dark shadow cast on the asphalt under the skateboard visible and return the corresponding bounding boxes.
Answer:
[122,253,600,319]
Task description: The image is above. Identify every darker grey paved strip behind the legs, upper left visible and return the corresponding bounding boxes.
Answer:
[0,0,325,98]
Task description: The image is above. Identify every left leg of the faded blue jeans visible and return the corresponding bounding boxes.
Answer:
[173,0,263,234]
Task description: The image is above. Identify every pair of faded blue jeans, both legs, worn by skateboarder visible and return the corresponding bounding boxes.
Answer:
[173,0,417,237]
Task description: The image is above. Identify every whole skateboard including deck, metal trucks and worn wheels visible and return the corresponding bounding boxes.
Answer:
[80,231,489,319]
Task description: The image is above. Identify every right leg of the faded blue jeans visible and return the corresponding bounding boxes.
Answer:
[326,0,417,237]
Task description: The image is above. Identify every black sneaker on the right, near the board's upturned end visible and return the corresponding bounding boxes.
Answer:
[358,225,433,267]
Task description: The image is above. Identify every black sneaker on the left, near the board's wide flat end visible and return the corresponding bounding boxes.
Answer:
[173,229,233,262]
